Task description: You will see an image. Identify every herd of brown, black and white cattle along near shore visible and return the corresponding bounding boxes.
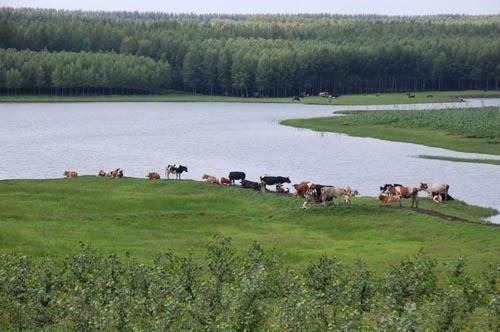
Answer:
[64,164,453,209]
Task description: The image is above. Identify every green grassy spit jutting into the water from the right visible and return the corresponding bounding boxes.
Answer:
[282,107,500,155]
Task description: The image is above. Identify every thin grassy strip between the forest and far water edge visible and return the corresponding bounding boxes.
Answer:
[0,90,500,105]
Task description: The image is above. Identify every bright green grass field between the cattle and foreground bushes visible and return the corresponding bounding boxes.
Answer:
[0,176,500,272]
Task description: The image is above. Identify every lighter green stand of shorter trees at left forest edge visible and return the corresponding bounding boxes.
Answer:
[0,49,170,95]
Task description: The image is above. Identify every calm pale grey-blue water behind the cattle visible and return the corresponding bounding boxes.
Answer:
[0,99,500,222]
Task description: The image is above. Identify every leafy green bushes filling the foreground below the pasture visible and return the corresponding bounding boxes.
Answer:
[0,236,500,331]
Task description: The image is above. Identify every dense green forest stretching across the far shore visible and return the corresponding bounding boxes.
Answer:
[0,8,500,97]
